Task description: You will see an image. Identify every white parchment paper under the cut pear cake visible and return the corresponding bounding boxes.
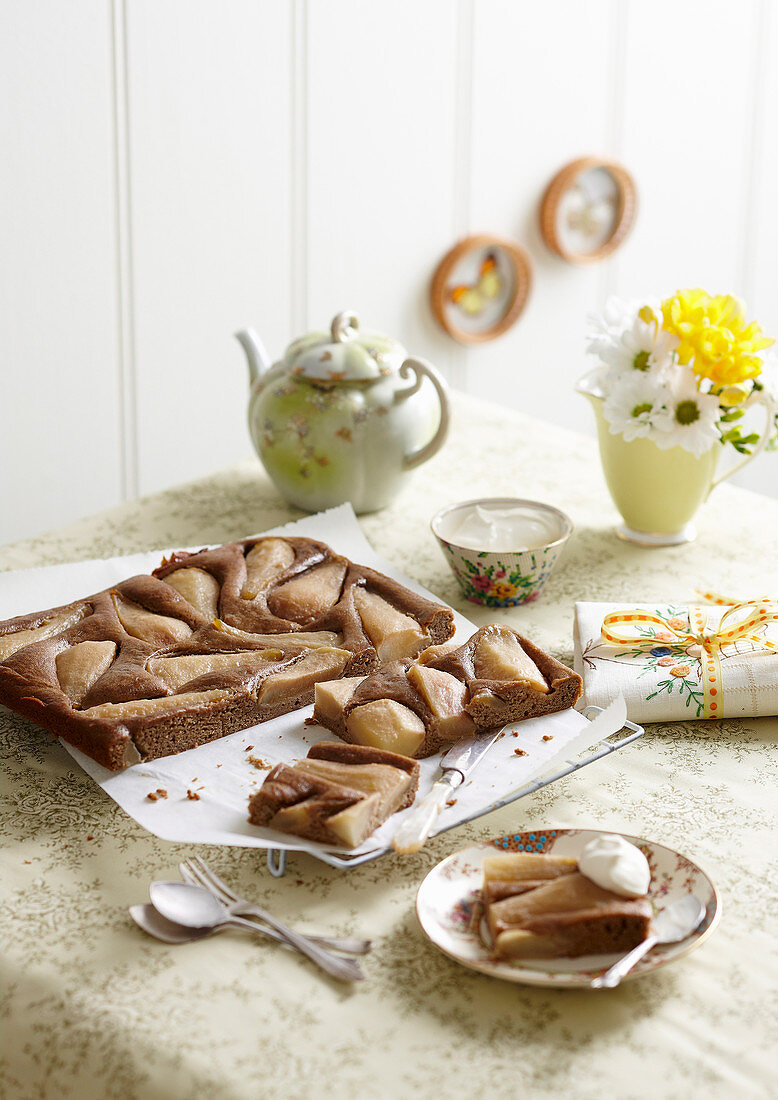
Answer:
[0,505,607,855]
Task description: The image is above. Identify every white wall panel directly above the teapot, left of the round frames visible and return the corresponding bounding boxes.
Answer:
[307,0,458,372]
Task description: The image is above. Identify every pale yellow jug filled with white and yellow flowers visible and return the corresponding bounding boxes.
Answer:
[577,290,778,546]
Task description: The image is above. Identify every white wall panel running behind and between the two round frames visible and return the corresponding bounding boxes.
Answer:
[468,0,615,437]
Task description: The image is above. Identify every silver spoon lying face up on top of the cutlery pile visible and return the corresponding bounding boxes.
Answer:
[149,882,364,981]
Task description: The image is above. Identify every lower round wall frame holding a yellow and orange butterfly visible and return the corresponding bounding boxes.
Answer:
[430,233,533,344]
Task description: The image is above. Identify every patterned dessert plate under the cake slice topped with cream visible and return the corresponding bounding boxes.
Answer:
[416,828,721,989]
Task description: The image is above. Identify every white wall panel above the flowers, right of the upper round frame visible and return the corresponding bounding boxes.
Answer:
[618,0,755,297]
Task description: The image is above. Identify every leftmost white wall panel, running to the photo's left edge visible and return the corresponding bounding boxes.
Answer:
[0,0,121,541]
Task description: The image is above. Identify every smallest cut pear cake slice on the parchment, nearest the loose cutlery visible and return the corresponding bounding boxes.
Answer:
[249,741,419,848]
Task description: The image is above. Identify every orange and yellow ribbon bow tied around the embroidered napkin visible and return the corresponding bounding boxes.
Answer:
[602,592,778,718]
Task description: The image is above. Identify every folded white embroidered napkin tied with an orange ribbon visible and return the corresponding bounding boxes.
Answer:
[574,600,778,722]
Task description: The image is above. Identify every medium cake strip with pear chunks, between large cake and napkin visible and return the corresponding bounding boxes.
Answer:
[311,625,581,757]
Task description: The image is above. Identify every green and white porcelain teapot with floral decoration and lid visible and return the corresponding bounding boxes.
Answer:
[235,311,449,513]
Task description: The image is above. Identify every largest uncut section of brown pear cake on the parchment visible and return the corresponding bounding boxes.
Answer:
[0,536,453,770]
